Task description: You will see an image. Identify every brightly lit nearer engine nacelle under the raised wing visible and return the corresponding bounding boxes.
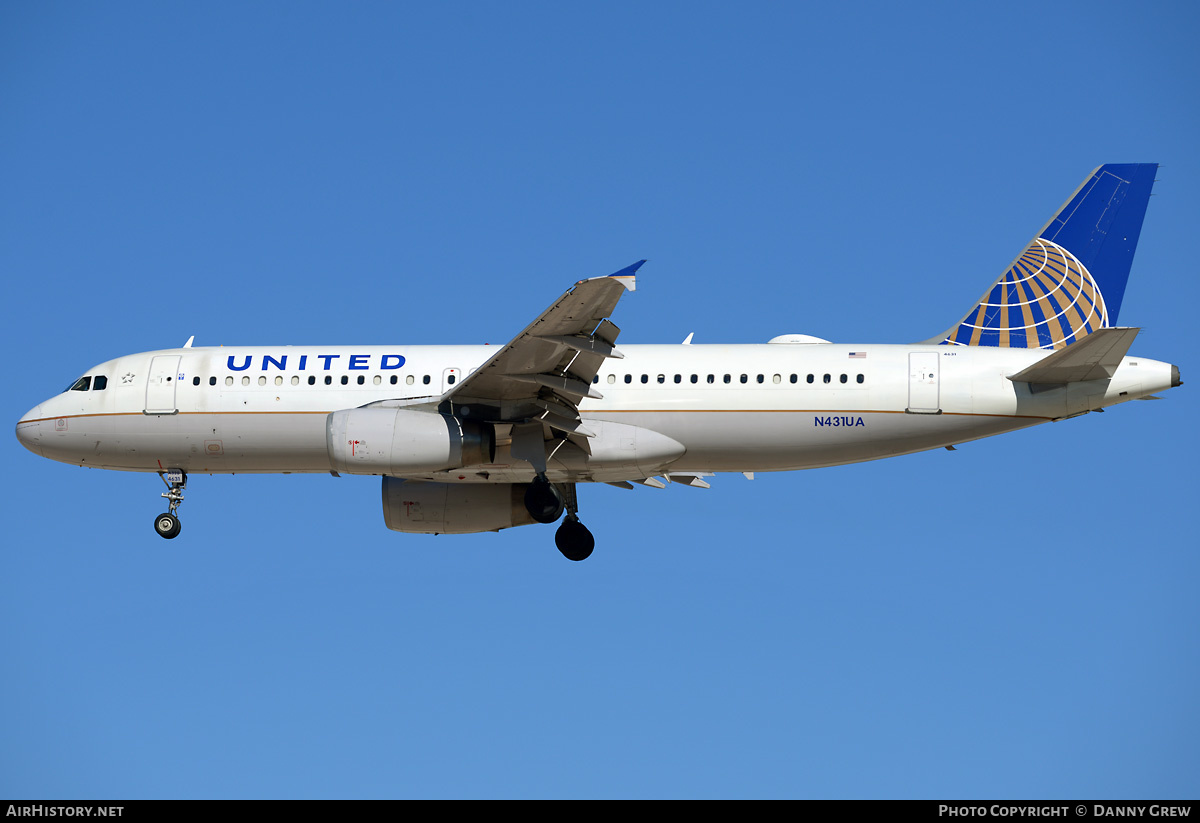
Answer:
[325,408,496,474]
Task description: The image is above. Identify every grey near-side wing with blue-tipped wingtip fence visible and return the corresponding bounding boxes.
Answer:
[440,260,646,424]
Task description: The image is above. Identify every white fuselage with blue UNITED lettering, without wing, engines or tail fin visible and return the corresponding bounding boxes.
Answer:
[17,343,1171,482]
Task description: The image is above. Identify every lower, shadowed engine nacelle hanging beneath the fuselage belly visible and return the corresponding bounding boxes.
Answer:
[383,476,534,534]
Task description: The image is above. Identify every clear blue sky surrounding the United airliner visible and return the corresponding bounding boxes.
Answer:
[0,2,1200,798]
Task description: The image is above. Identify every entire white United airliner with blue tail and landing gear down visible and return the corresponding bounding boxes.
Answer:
[17,164,1180,560]
